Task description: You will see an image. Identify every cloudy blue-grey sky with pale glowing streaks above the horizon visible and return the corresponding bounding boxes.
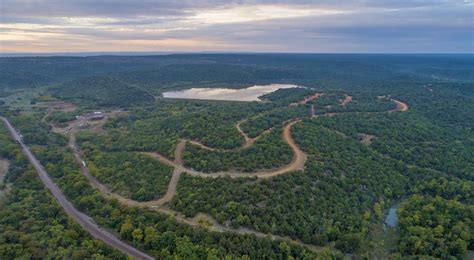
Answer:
[0,0,474,53]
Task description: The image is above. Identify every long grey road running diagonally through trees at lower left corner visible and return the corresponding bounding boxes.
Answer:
[0,117,154,259]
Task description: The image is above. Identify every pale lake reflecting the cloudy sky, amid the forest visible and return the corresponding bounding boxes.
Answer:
[163,84,298,101]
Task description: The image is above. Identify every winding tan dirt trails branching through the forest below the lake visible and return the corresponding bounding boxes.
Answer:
[61,93,408,252]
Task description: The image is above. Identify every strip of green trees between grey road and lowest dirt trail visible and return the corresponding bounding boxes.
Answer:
[0,111,326,259]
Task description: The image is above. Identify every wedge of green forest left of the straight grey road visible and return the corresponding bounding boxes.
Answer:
[0,124,126,259]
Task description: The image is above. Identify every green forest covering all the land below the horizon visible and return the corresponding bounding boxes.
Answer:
[0,54,474,259]
